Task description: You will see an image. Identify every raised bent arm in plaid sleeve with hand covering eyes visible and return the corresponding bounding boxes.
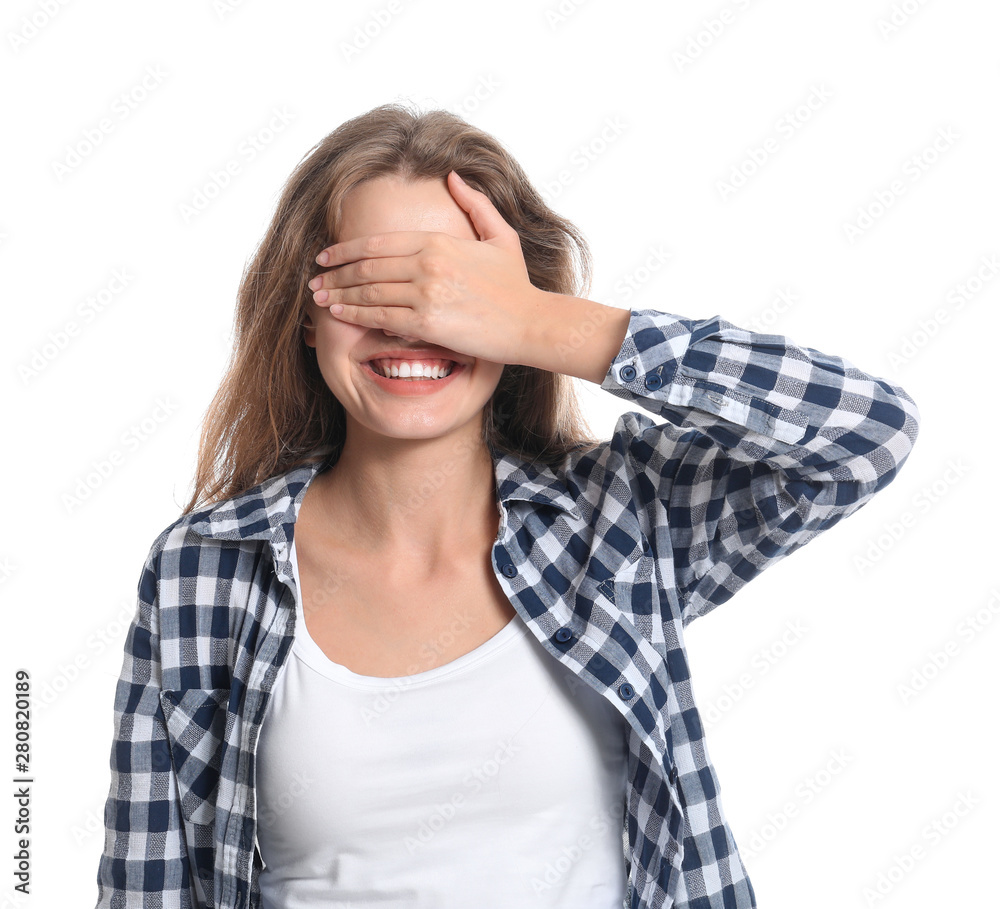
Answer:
[310,173,919,621]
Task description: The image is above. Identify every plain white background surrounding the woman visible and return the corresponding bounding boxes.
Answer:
[0,0,1000,909]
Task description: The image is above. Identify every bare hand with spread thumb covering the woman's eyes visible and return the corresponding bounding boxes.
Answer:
[309,171,553,365]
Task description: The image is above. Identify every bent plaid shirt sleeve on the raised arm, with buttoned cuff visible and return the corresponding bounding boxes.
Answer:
[600,309,919,624]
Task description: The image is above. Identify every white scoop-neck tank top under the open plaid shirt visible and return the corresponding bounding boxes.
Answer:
[256,545,627,909]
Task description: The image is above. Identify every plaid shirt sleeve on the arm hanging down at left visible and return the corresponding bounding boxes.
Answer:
[97,536,200,909]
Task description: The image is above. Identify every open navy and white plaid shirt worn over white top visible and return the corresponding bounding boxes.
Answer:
[98,309,919,909]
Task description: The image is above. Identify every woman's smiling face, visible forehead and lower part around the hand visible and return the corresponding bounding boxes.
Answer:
[305,177,503,439]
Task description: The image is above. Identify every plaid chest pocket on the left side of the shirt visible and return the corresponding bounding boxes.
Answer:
[160,688,230,826]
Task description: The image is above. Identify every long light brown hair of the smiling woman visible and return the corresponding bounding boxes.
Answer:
[184,103,598,513]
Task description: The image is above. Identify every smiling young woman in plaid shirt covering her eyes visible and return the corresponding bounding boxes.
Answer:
[98,105,918,909]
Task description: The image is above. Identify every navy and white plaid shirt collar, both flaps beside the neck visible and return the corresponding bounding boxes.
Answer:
[189,445,581,543]
